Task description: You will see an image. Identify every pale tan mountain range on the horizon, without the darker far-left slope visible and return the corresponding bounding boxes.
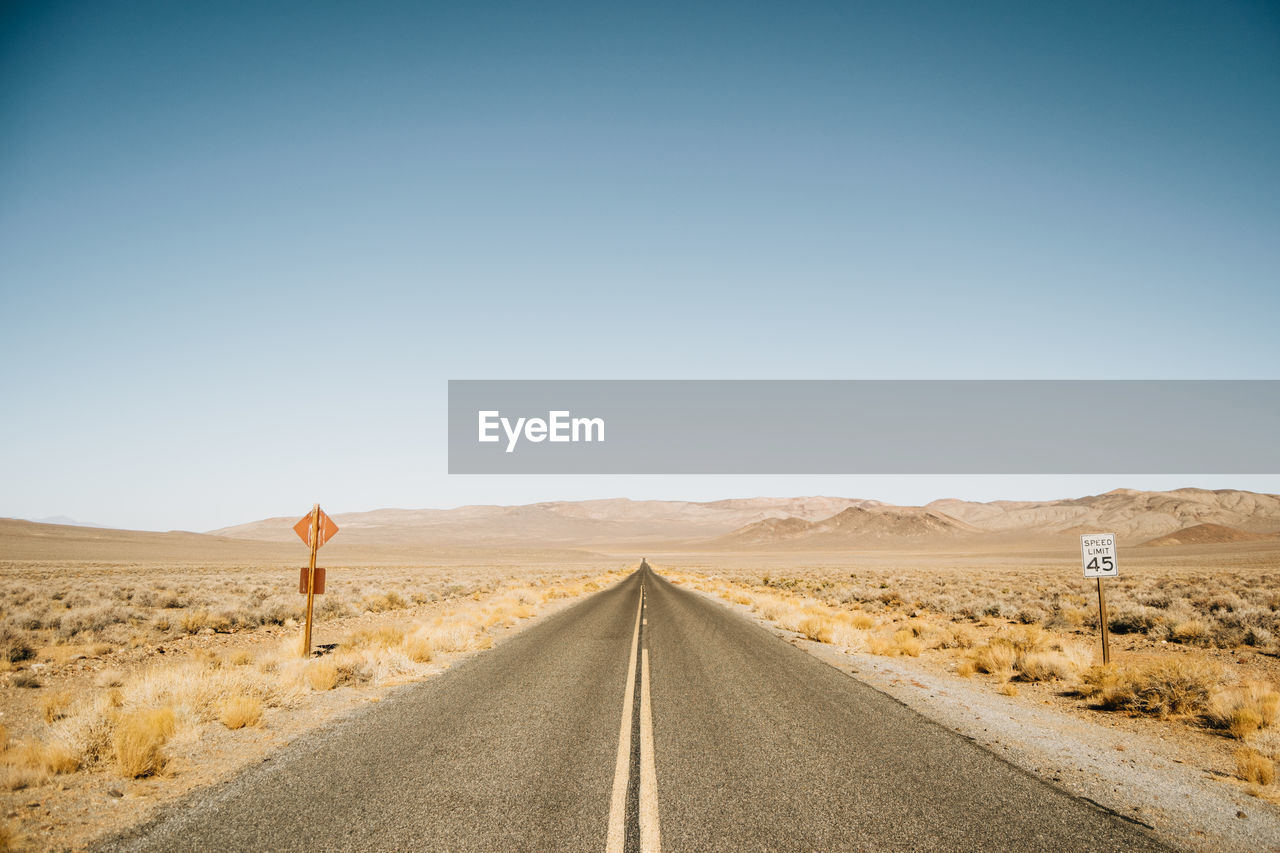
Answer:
[204,489,1280,551]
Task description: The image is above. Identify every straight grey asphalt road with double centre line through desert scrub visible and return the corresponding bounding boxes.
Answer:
[106,567,1164,853]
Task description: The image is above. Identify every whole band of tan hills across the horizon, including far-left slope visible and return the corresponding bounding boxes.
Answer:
[10,489,1280,562]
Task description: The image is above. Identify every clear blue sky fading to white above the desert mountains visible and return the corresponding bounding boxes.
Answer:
[0,0,1280,529]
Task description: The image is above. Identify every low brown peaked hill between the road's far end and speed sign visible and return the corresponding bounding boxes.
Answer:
[708,506,983,551]
